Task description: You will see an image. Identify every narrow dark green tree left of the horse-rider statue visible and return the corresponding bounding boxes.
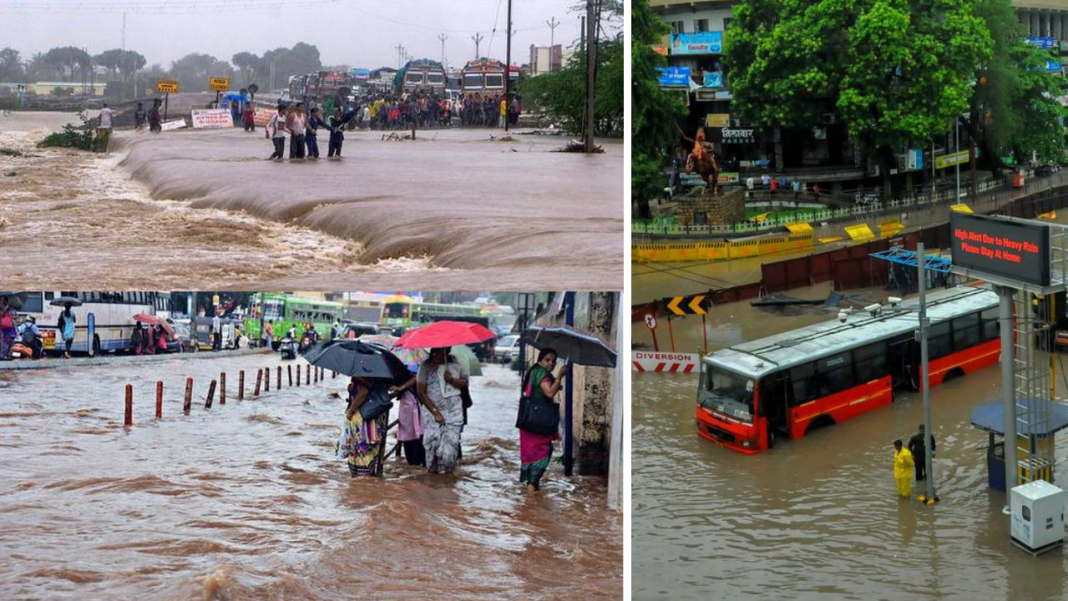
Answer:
[630,0,685,218]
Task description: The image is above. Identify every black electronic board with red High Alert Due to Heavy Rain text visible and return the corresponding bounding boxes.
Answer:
[949,212,1050,286]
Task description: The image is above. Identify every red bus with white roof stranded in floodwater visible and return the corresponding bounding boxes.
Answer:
[695,286,1001,455]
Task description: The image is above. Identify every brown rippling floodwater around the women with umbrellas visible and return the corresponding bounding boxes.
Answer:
[0,354,623,601]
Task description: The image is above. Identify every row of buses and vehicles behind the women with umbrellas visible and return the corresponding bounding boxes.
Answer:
[5,291,516,360]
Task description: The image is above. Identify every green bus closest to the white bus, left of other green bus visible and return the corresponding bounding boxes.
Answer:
[245,292,345,343]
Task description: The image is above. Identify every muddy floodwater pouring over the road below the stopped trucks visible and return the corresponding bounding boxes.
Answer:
[0,113,625,289]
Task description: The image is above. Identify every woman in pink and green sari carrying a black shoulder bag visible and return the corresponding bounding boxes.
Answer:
[519,348,567,492]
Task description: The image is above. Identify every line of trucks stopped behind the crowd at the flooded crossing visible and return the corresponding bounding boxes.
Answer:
[287,59,519,102]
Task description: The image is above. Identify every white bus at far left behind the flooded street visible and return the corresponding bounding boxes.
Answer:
[18,291,170,357]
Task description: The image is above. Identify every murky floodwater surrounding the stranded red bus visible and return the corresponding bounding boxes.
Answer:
[631,289,1068,600]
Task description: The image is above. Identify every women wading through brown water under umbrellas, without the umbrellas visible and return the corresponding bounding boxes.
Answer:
[339,348,565,491]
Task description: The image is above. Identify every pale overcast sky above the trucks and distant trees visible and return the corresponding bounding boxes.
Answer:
[0,0,610,68]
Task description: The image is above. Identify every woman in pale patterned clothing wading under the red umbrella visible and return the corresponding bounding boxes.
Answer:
[415,348,468,474]
